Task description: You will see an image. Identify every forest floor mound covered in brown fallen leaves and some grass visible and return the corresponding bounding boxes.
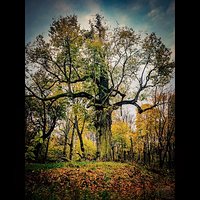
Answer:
[25,161,175,200]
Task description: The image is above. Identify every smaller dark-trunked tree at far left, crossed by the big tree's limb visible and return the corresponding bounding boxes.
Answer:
[26,71,67,162]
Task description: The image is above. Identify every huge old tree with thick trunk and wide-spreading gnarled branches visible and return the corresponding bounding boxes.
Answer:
[25,14,175,160]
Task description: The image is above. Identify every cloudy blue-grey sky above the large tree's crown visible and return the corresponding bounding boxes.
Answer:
[25,0,175,58]
